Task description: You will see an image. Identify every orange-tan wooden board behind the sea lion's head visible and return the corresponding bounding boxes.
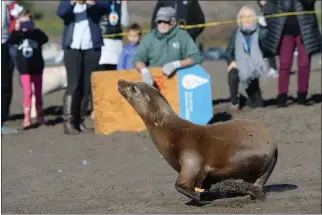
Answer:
[91,67,180,134]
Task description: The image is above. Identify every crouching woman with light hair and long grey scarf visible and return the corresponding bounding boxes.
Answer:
[225,6,267,111]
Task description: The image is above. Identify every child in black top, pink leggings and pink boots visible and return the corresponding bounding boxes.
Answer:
[8,10,48,128]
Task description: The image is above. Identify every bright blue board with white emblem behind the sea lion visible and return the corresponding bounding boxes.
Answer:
[177,65,213,125]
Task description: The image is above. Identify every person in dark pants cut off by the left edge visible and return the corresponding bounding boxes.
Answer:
[1,1,18,134]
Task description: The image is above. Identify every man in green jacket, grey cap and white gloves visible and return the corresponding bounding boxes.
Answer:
[133,7,202,85]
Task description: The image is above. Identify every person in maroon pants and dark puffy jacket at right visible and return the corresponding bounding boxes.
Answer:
[263,0,322,107]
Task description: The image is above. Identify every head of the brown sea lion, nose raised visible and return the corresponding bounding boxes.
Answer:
[118,80,172,118]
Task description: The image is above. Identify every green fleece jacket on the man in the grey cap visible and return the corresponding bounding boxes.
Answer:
[132,26,202,67]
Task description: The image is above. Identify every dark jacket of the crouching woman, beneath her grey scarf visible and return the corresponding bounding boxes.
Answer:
[225,26,267,65]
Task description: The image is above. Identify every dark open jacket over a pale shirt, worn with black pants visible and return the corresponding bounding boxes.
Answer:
[57,0,110,49]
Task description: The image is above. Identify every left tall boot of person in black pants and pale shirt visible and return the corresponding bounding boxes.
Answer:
[63,95,79,135]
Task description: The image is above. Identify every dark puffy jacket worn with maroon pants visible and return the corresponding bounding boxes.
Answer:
[263,0,322,56]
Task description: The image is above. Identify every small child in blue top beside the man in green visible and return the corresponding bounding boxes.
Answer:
[117,23,142,70]
